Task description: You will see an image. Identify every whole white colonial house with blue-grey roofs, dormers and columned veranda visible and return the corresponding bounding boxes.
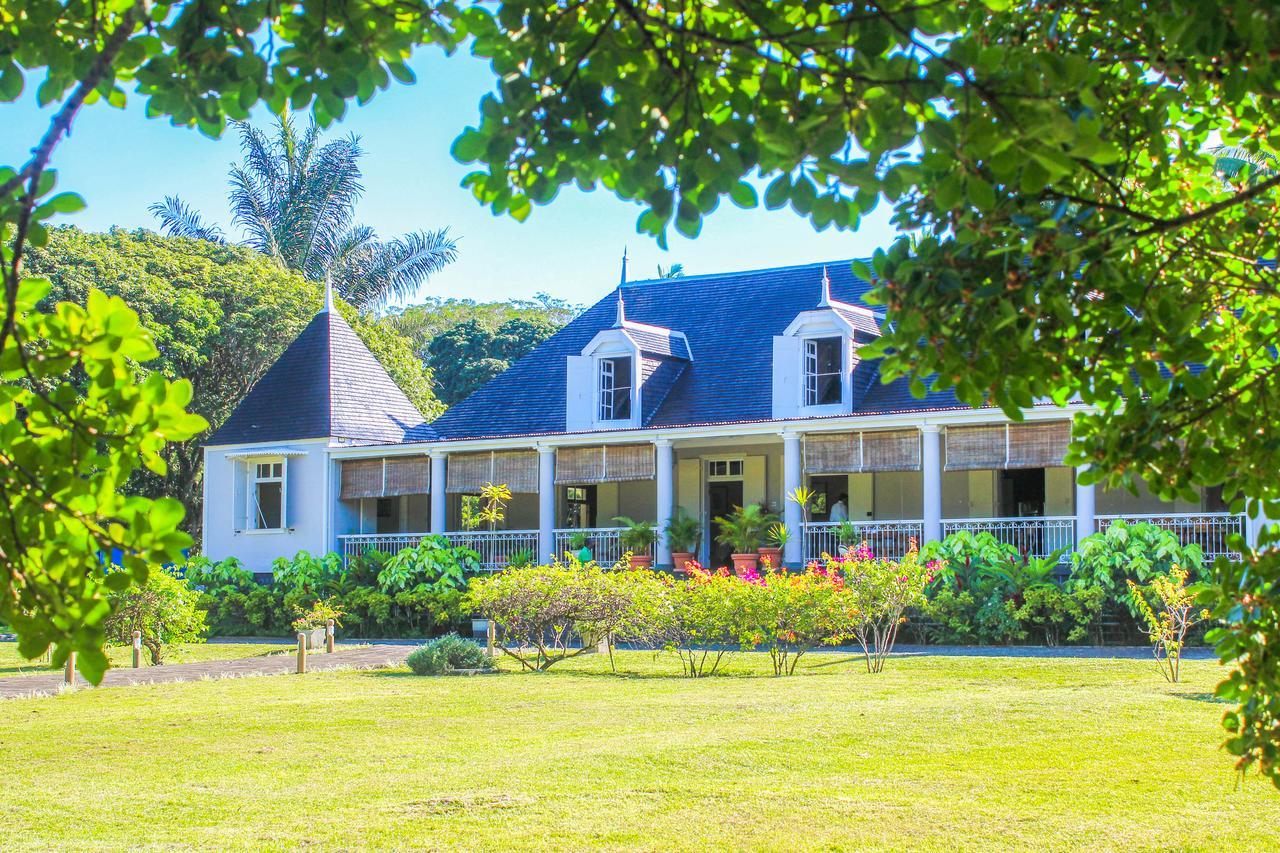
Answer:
[204,261,1253,573]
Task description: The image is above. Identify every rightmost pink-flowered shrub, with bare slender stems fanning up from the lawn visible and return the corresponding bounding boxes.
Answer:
[813,540,942,672]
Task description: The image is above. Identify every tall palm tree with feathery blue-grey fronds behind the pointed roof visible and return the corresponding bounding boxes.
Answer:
[151,117,458,310]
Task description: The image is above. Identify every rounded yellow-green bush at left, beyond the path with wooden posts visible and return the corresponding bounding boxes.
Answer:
[104,567,205,665]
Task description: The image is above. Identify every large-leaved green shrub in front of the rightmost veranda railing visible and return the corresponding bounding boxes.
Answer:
[1068,520,1204,596]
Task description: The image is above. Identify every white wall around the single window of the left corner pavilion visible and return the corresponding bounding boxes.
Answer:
[201,439,339,573]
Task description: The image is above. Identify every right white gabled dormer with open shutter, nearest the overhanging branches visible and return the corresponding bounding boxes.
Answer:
[773,269,879,418]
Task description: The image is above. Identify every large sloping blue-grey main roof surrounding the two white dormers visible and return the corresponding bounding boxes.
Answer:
[433,261,966,439]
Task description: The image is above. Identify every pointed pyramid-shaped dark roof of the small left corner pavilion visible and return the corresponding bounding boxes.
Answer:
[206,311,436,444]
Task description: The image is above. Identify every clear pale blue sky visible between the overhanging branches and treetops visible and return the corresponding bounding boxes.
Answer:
[0,50,892,302]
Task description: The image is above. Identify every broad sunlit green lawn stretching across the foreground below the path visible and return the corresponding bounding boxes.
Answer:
[0,652,1280,850]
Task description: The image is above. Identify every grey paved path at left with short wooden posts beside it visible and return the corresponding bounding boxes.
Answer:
[0,644,413,699]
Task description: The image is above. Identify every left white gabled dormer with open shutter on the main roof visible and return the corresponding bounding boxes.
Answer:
[564,288,692,432]
